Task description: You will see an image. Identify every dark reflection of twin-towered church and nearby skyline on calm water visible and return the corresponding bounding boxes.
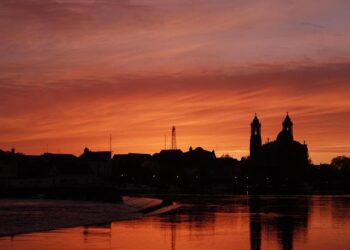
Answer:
[160,196,310,250]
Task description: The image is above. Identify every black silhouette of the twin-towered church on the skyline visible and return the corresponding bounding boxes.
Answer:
[250,113,309,183]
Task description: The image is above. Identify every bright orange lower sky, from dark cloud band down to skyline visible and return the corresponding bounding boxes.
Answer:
[0,64,350,161]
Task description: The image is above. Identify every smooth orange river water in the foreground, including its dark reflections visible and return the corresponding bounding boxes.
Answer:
[0,196,350,250]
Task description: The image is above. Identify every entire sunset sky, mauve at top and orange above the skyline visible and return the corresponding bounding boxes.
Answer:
[0,0,350,163]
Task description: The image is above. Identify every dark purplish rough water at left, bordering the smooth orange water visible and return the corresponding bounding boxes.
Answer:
[0,197,177,236]
